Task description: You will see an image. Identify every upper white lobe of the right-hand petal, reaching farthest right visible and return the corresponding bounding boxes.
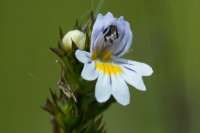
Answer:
[115,58,153,76]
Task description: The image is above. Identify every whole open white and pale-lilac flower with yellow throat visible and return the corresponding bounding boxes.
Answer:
[75,12,153,105]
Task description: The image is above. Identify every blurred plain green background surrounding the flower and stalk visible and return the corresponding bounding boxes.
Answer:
[0,0,200,133]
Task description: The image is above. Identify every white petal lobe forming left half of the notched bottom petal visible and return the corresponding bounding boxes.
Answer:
[95,72,111,103]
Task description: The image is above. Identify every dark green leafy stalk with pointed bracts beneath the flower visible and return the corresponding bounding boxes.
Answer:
[42,13,114,133]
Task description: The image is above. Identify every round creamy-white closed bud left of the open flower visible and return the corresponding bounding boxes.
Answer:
[62,30,86,51]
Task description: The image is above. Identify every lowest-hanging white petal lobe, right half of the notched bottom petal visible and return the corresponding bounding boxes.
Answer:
[112,75,130,106]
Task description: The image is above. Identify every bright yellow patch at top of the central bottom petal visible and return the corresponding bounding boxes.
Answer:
[96,62,122,75]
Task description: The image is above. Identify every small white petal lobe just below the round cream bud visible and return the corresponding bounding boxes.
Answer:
[75,50,91,63]
